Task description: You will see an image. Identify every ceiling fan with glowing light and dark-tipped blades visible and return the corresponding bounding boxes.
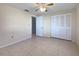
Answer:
[24,3,54,12]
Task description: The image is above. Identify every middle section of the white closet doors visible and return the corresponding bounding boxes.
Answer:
[59,15,67,39]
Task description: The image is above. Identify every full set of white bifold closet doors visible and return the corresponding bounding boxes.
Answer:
[51,13,71,40]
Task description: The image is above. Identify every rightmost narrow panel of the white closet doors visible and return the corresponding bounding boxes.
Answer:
[65,13,72,40]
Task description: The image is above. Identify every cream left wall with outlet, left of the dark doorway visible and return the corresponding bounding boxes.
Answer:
[0,5,32,47]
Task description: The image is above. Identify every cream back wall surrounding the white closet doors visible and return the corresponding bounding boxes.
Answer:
[42,9,76,42]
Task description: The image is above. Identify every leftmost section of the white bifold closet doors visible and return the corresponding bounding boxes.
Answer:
[51,16,59,37]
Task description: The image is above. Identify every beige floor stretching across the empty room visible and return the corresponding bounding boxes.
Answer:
[0,37,79,56]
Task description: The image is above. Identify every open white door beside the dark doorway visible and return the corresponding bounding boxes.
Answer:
[36,16,43,36]
